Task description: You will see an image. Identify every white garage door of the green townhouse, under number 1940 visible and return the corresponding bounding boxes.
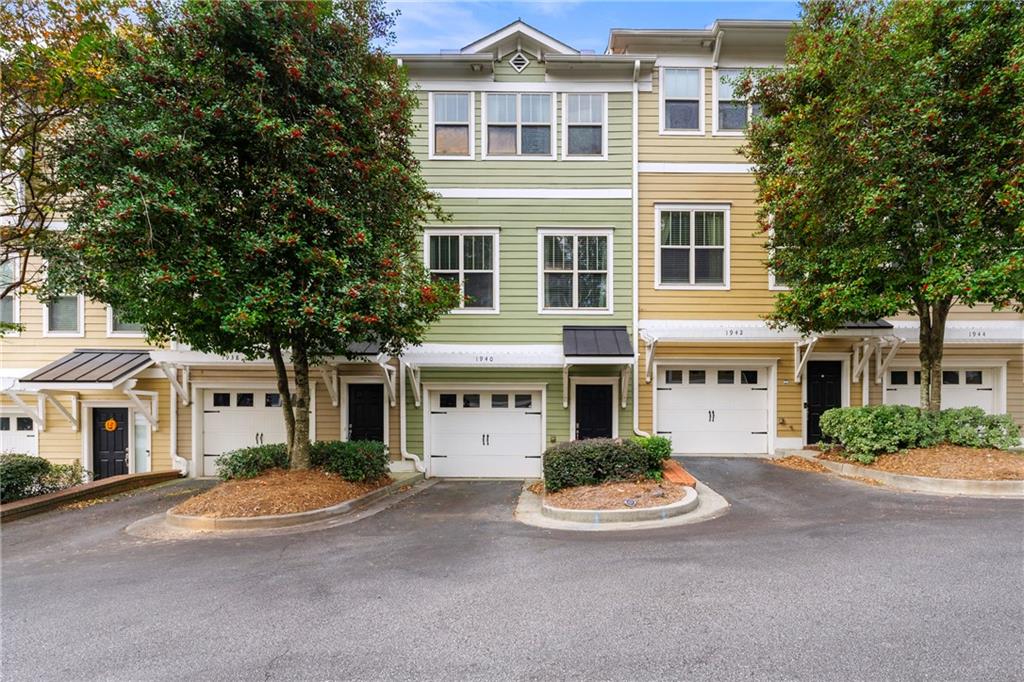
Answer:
[429,388,544,478]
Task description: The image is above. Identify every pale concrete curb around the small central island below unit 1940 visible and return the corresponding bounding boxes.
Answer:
[515,480,729,530]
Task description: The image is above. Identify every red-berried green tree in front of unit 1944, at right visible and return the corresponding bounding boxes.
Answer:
[745,0,1024,410]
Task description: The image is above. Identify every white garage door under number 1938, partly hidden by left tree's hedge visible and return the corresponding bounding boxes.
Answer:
[203,388,285,476]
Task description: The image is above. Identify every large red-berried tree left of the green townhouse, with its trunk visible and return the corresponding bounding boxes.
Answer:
[47,0,458,468]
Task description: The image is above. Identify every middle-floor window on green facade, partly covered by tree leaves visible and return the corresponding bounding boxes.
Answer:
[426,230,499,312]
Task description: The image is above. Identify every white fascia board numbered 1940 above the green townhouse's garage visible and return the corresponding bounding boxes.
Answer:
[402,343,565,369]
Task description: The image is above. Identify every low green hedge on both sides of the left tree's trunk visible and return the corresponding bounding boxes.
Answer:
[217,440,388,481]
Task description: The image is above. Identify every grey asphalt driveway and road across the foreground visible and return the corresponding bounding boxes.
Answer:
[0,458,1024,681]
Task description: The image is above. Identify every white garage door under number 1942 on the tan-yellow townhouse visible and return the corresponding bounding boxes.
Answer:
[656,366,768,455]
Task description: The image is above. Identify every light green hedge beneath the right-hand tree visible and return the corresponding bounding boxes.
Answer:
[821,404,1020,463]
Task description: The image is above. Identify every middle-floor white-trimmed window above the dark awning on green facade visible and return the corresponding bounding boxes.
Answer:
[540,230,611,312]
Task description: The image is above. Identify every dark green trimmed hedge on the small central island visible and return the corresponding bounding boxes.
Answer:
[544,436,672,493]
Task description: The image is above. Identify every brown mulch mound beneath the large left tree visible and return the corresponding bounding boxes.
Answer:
[171,469,391,518]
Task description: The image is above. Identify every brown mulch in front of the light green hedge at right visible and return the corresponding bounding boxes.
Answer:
[818,444,1024,480]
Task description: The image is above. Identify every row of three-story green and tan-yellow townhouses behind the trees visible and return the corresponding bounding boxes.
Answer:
[0,22,1024,477]
